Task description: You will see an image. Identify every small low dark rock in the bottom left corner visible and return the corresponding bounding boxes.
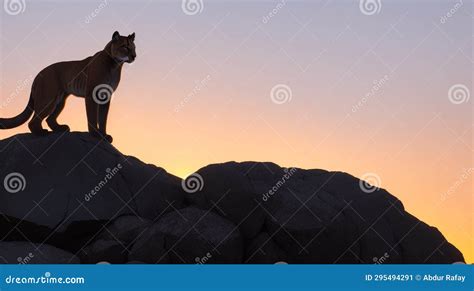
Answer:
[0,241,80,265]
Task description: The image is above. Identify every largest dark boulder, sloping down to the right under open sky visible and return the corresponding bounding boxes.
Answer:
[187,162,464,263]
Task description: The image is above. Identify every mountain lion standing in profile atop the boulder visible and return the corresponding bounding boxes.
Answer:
[0,31,137,142]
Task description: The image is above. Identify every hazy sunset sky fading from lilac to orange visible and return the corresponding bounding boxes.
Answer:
[0,0,474,263]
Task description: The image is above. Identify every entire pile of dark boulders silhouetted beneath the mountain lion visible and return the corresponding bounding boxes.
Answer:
[0,133,464,264]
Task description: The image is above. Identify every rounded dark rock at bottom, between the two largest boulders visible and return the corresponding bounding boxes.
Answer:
[143,207,243,264]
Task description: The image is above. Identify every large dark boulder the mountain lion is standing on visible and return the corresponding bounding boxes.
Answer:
[0,133,184,231]
